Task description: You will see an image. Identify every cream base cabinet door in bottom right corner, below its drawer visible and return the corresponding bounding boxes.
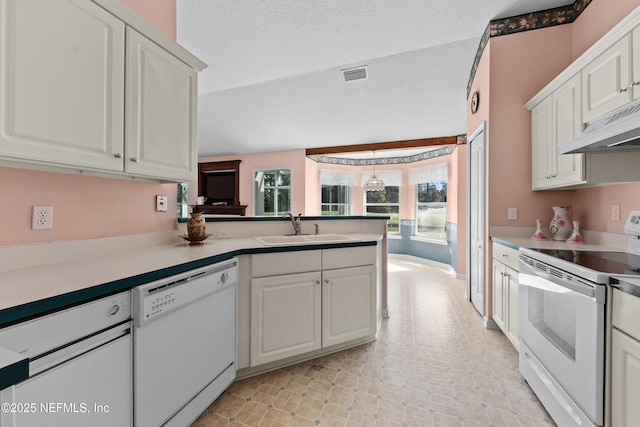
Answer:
[611,329,640,427]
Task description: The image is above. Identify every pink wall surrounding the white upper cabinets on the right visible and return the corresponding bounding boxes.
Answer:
[480,0,640,233]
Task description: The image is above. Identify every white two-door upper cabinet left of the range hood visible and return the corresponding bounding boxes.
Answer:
[531,74,585,190]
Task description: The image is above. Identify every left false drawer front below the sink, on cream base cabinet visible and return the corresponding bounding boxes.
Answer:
[251,250,322,277]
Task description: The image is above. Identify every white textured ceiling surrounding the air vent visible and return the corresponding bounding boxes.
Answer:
[176,0,573,156]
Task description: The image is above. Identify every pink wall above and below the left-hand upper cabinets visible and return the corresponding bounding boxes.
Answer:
[0,0,176,246]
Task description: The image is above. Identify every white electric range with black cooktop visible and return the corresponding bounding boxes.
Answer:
[519,211,640,427]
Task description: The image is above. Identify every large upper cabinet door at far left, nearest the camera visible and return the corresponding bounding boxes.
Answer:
[0,0,125,171]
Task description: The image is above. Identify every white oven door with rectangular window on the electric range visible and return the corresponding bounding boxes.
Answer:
[519,259,606,425]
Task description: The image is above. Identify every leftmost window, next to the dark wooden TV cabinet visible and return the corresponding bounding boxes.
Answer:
[253,169,291,216]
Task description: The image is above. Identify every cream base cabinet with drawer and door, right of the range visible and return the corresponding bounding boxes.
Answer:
[610,289,640,427]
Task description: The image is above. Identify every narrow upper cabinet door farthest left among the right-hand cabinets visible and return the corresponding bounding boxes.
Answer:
[531,96,557,190]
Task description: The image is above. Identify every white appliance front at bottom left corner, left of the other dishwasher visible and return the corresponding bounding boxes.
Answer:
[0,291,133,427]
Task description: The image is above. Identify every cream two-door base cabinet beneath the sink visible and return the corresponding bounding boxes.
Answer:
[245,246,377,367]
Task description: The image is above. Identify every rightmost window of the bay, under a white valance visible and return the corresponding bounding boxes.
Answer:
[416,180,447,239]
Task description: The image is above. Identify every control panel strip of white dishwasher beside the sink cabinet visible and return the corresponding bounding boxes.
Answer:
[133,258,238,326]
